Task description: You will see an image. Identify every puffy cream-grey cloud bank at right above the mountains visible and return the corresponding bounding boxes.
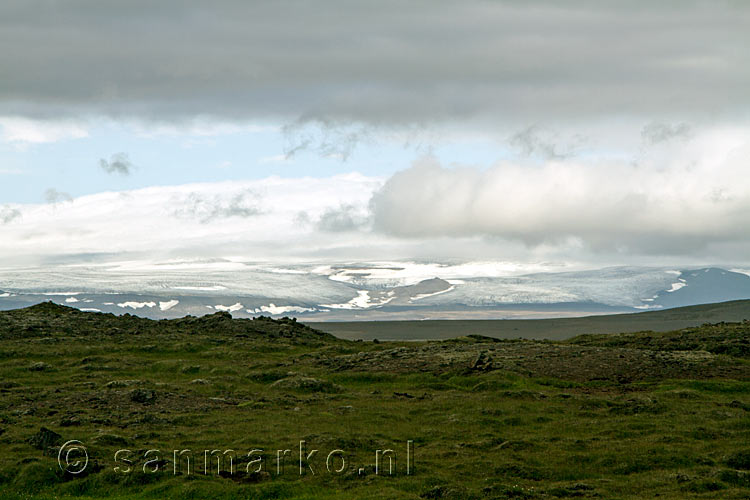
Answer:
[370,132,750,254]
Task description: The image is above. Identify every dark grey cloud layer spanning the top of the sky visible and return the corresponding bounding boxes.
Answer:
[0,0,750,127]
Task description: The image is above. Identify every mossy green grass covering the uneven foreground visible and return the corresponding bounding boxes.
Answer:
[0,302,750,500]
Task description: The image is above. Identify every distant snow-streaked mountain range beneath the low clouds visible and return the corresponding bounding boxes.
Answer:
[0,261,750,321]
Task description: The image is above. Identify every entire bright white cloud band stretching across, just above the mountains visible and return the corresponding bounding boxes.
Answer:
[0,125,750,268]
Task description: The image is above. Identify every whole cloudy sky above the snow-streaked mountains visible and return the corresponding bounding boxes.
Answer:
[0,0,750,268]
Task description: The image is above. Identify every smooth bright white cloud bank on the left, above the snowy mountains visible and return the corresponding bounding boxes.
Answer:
[0,174,382,264]
